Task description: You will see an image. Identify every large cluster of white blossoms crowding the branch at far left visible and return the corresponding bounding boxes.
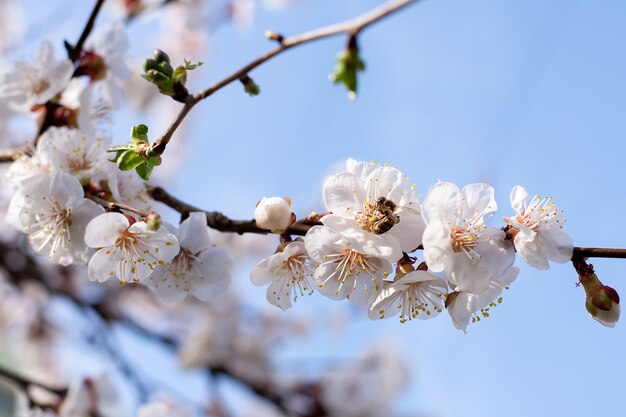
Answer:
[0,24,232,301]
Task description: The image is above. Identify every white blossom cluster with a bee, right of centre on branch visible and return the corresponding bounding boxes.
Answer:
[251,160,573,331]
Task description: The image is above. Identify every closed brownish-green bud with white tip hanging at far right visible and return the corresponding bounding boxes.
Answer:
[580,265,620,327]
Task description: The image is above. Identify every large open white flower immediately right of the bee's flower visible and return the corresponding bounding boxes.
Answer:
[422,182,515,294]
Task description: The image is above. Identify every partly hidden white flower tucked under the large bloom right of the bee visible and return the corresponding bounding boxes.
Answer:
[446,266,519,333]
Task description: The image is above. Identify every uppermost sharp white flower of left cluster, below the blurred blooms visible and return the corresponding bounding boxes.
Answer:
[36,127,108,180]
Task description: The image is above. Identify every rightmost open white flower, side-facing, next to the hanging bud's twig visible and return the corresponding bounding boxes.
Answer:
[504,185,574,269]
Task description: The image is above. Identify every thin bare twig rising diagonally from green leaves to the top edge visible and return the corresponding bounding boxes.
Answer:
[151,0,420,155]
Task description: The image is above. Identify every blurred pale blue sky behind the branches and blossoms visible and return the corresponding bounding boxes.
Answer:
[3,0,626,417]
